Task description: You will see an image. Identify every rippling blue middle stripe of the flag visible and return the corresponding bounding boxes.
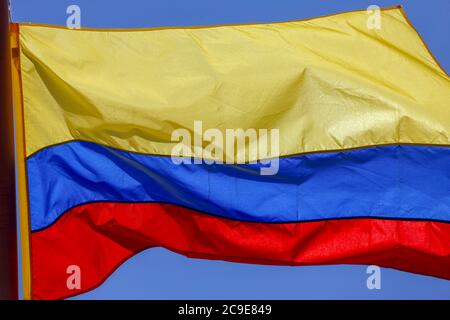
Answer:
[27,142,450,230]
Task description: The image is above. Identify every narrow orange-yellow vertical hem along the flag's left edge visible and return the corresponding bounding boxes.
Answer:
[11,24,31,300]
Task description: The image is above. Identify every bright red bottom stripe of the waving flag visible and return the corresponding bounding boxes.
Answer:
[31,203,450,299]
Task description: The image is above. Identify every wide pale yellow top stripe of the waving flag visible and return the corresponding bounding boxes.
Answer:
[20,8,450,156]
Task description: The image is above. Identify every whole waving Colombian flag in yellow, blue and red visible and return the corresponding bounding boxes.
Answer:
[12,7,450,299]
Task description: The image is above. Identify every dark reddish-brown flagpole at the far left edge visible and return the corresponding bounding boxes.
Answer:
[0,0,18,299]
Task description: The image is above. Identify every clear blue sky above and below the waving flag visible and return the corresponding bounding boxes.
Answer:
[11,0,450,299]
